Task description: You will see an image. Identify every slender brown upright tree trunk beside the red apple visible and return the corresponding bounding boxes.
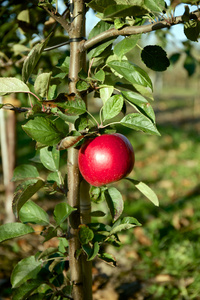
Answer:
[67,0,92,300]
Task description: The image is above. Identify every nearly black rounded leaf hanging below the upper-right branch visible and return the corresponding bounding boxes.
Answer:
[141,45,170,72]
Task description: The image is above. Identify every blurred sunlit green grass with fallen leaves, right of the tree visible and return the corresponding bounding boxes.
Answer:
[110,90,200,300]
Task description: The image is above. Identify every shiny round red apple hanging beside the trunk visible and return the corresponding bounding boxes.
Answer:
[78,133,135,186]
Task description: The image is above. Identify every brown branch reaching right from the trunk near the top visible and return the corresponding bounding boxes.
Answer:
[79,11,200,52]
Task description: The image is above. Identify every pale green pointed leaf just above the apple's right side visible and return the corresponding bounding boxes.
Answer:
[120,113,160,135]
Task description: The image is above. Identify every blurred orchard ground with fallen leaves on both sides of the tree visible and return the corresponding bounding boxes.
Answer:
[0,66,200,300]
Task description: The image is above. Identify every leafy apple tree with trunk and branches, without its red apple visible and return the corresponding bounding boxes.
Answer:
[0,0,200,300]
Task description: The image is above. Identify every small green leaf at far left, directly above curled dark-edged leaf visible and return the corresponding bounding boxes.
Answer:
[12,164,40,181]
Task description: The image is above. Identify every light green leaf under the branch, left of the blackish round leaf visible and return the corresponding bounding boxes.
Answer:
[113,34,141,60]
